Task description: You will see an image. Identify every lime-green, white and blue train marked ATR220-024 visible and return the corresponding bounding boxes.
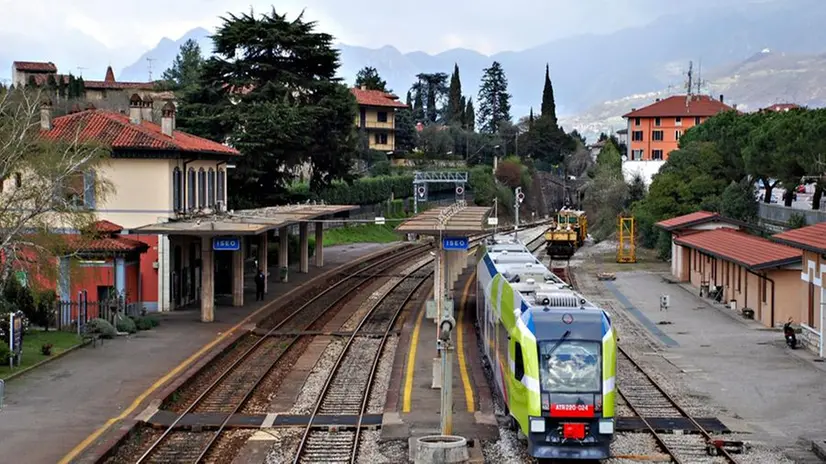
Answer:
[476,236,617,460]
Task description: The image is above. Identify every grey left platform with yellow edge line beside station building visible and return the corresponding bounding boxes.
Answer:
[0,244,389,464]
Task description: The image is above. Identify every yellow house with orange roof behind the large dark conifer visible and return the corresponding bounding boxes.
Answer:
[350,86,407,152]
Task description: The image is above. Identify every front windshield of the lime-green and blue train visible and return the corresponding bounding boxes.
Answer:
[539,338,602,393]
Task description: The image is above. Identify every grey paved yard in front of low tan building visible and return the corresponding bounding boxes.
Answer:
[606,272,826,447]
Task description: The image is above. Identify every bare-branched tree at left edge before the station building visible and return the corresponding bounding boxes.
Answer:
[0,89,113,282]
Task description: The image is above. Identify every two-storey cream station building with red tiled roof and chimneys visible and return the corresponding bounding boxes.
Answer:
[40,93,240,311]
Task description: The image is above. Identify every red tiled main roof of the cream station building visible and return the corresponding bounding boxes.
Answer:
[40,109,240,156]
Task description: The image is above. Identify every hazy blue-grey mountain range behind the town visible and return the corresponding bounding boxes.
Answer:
[0,0,826,141]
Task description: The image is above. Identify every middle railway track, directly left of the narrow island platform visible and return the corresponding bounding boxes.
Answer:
[293,263,433,464]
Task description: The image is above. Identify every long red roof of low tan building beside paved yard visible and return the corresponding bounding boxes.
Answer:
[674,229,803,270]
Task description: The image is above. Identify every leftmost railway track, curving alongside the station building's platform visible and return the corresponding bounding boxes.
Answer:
[136,245,429,463]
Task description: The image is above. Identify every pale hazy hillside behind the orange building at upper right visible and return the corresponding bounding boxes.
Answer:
[560,52,826,140]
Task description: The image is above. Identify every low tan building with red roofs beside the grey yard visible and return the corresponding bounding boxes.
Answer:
[657,211,802,327]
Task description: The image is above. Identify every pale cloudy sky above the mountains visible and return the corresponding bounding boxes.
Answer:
[0,0,760,53]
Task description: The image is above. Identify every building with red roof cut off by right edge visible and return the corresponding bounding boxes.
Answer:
[772,222,826,358]
